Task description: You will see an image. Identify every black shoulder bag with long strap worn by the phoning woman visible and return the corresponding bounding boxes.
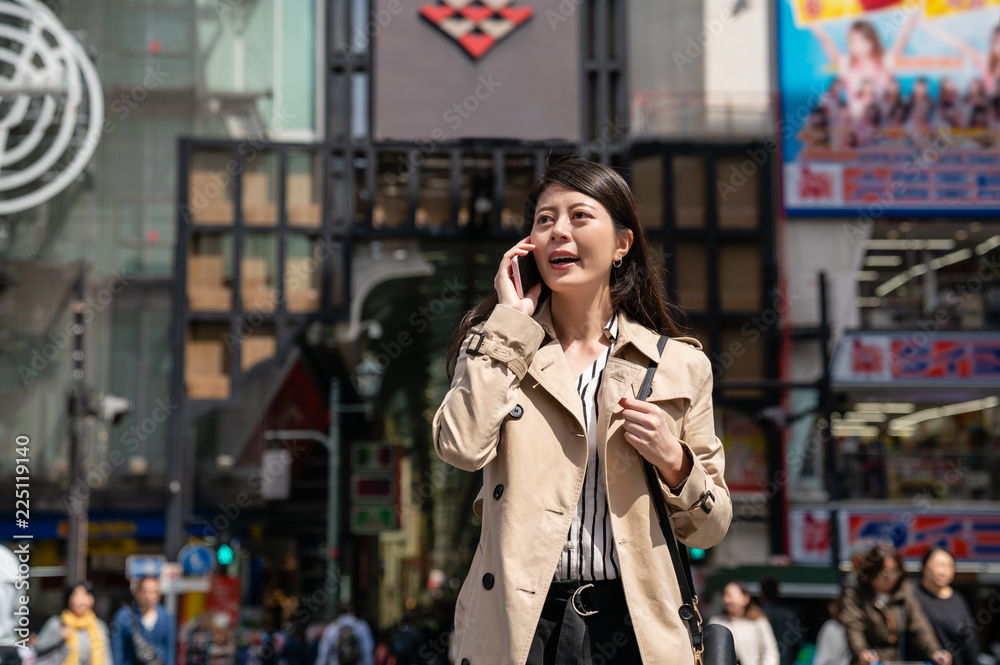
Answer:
[637,335,736,665]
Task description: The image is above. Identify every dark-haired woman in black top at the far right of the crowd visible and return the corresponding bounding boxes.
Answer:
[914,547,979,665]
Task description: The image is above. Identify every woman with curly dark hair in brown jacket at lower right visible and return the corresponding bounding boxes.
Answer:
[844,543,951,665]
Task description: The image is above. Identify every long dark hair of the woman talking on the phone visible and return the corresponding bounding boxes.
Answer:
[445,157,681,379]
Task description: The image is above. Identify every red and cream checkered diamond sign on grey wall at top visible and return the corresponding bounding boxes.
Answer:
[420,0,534,60]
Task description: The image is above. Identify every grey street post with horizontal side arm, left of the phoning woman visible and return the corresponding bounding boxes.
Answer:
[264,378,371,620]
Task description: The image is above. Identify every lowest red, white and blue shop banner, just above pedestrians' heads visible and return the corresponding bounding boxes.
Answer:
[788,504,1000,565]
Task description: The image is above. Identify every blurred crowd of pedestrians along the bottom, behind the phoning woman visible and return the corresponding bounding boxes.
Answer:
[0,544,1000,665]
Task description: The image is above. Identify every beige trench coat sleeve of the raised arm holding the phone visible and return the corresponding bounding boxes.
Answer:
[434,305,545,471]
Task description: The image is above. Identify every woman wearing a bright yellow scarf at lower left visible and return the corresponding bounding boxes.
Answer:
[36,582,112,665]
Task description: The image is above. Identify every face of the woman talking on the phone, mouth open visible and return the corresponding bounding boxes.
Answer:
[531,185,632,293]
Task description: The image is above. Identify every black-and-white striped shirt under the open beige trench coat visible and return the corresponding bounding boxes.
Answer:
[555,315,619,580]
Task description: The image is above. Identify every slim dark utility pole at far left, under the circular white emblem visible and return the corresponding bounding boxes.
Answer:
[66,266,90,584]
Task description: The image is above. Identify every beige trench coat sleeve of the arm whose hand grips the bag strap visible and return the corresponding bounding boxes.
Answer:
[659,354,733,549]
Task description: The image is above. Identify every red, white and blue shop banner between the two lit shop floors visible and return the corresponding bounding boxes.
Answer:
[832,331,1000,388]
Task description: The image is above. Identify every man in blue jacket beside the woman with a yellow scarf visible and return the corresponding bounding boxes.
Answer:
[111,577,176,665]
